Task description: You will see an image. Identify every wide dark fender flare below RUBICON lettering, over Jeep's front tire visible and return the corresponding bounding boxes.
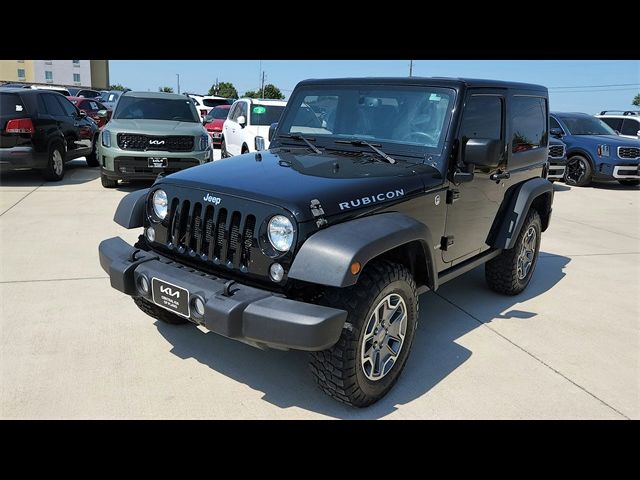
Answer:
[288,212,438,288]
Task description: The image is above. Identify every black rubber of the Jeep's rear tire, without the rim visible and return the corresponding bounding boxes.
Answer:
[484,209,542,295]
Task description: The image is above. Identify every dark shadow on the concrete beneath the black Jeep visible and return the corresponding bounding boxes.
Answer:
[155,252,570,419]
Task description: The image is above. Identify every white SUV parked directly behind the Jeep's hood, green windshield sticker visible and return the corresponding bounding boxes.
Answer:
[222,98,287,157]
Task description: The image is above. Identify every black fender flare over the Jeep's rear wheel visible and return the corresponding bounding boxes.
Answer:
[489,177,553,250]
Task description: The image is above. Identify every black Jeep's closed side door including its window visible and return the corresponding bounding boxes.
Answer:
[441,89,507,265]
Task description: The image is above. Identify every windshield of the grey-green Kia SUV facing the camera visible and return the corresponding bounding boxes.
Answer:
[113,95,200,123]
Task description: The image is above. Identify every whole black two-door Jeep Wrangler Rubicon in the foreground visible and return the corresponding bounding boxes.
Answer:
[99,78,553,407]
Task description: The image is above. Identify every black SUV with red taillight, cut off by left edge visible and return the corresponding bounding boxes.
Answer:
[0,89,98,181]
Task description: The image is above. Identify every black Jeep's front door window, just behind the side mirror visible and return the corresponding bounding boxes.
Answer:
[461,95,502,142]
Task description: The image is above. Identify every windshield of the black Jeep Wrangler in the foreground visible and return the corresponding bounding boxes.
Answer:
[279,85,455,160]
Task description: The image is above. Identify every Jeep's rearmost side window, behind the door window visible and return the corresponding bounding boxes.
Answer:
[511,96,547,153]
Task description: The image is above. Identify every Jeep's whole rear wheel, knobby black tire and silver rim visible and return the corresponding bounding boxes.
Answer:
[484,210,542,295]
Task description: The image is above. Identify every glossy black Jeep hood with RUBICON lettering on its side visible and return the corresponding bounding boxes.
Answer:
[157,149,443,222]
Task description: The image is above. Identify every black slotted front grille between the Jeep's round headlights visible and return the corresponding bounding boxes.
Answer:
[167,198,256,272]
